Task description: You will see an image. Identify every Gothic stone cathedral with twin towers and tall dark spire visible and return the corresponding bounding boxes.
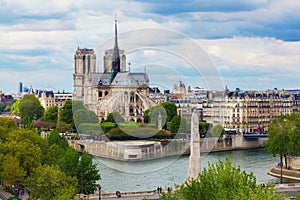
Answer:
[73,20,154,122]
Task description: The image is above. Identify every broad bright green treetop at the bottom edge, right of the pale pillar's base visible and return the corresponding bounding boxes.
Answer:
[161,158,284,200]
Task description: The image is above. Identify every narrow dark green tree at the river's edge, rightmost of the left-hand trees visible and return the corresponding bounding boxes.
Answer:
[77,152,101,194]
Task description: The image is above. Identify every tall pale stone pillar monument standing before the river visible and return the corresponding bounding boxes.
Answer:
[187,111,200,180]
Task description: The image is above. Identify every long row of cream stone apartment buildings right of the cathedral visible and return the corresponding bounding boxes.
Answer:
[203,90,300,133]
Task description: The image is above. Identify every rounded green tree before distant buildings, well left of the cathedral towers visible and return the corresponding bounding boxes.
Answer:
[19,94,44,127]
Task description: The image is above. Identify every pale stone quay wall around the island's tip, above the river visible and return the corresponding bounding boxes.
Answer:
[69,135,267,161]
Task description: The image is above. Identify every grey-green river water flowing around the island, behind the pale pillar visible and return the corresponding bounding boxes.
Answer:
[94,149,279,192]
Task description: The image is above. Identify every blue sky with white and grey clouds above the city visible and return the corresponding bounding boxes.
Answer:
[0,0,300,92]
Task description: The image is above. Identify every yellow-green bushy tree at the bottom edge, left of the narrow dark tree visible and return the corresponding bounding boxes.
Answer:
[26,165,77,200]
